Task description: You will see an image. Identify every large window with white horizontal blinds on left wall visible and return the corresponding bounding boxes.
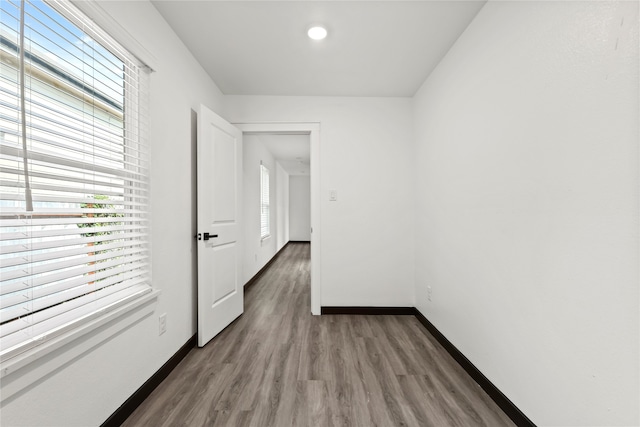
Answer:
[0,0,151,361]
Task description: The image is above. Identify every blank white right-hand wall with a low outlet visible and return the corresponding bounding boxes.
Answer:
[414,1,640,426]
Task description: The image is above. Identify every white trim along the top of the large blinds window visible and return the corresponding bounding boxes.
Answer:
[70,0,158,71]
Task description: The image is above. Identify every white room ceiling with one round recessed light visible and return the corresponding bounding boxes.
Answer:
[153,0,486,96]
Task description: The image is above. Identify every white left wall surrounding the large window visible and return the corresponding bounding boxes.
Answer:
[0,1,229,427]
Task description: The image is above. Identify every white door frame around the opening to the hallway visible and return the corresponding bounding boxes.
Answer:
[232,122,322,315]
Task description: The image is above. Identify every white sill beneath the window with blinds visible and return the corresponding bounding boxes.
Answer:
[0,289,160,402]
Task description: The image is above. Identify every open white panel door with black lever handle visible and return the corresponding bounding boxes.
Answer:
[197,106,244,347]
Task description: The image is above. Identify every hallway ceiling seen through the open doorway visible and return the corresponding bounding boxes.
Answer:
[245,134,311,175]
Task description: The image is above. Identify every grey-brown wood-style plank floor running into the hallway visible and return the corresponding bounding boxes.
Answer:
[123,243,513,427]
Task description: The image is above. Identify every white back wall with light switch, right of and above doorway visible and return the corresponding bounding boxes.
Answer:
[225,96,414,306]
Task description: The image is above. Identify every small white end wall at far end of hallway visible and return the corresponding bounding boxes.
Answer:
[289,175,311,242]
